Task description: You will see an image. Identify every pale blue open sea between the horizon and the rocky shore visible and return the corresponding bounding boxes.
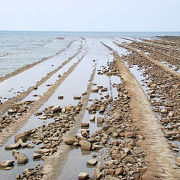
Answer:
[0,31,180,77]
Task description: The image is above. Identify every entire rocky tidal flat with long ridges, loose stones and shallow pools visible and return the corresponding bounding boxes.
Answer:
[0,37,180,180]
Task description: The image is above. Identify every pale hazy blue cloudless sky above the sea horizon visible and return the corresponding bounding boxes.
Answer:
[0,0,180,31]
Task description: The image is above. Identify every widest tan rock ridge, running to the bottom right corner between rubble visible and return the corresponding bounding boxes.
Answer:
[102,43,179,179]
